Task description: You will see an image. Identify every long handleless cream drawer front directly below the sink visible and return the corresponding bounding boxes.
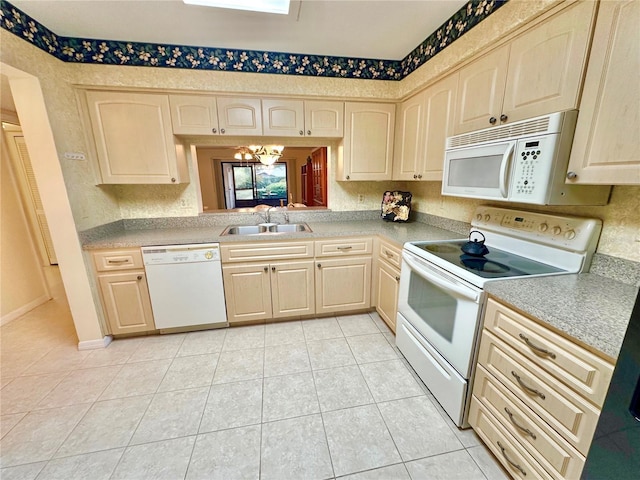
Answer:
[220,241,313,263]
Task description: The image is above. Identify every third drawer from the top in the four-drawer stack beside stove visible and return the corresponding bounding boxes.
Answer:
[473,366,585,478]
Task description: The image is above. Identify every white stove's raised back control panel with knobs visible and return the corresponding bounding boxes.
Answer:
[471,206,602,251]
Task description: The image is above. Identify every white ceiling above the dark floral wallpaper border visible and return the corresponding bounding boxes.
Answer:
[10,0,467,60]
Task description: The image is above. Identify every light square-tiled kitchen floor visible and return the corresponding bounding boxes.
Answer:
[0,268,508,480]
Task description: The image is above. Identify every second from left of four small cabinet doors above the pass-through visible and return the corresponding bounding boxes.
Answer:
[217,97,262,135]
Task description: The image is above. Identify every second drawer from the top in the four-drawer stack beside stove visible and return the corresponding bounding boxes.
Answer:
[478,330,600,455]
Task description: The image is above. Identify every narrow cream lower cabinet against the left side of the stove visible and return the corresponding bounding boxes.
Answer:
[374,240,402,333]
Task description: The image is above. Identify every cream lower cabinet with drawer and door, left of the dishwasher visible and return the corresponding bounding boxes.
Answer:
[93,249,156,335]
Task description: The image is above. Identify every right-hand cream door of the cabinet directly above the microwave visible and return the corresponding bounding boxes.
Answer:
[501,2,596,122]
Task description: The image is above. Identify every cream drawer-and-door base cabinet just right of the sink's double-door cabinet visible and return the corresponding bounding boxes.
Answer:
[315,238,373,314]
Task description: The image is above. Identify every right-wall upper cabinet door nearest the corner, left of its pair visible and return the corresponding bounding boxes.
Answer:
[393,92,425,180]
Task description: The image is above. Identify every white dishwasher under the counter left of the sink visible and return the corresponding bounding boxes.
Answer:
[142,243,229,333]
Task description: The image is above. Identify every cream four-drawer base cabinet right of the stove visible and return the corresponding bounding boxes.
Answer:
[469,299,613,479]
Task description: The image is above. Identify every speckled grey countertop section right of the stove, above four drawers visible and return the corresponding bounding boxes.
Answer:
[485,273,638,360]
